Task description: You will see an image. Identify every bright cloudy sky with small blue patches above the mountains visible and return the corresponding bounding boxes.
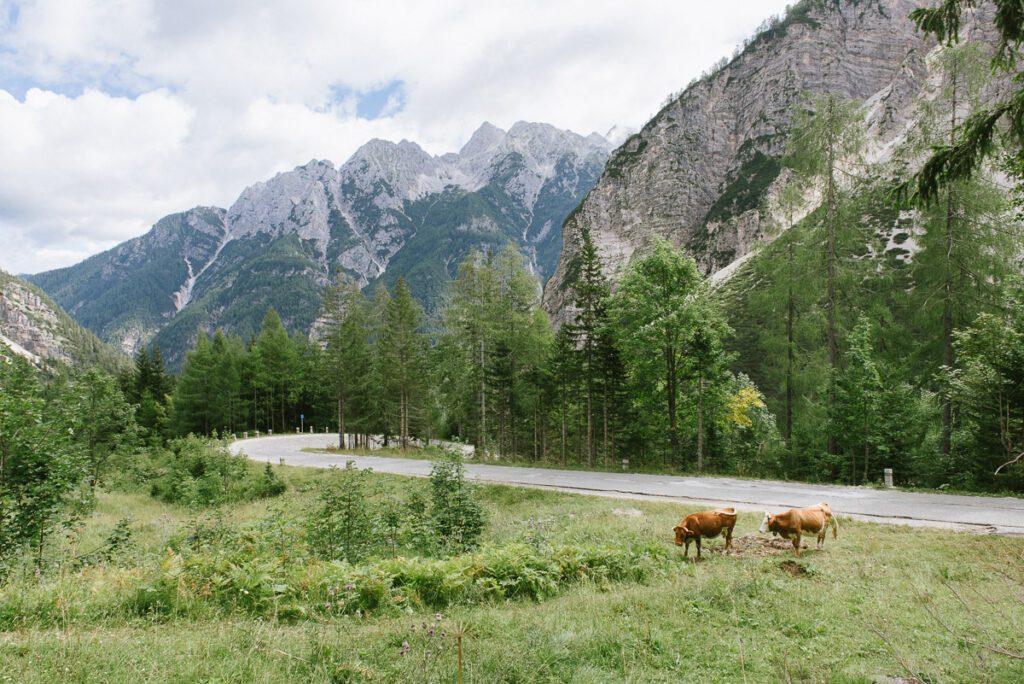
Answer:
[0,0,792,273]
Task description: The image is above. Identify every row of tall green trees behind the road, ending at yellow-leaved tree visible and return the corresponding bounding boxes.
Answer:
[165,241,778,470]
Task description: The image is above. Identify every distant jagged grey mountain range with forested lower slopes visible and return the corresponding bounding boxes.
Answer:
[31,122,610,368]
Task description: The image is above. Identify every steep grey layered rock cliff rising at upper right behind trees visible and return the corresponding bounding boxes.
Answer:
[544,0,933,322]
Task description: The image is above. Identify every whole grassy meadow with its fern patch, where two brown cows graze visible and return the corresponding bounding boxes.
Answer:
[0,454,1024,684]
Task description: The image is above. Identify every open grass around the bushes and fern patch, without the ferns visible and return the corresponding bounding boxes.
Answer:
[0,467,1024,684]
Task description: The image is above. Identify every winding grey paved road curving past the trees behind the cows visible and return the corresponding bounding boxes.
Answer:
[231,435,1024,535]
